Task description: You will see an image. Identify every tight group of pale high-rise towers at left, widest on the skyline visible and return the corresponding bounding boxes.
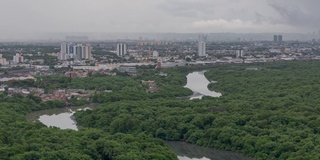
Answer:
[57,43,92,61]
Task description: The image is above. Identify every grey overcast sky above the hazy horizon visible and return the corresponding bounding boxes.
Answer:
[0,0,320,36]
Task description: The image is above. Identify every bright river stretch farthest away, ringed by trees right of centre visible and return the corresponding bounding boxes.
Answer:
[184,71,222,99]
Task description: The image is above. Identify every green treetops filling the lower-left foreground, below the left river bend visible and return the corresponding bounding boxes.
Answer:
[0,95,177,160]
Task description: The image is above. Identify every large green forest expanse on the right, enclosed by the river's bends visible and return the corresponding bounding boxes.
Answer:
[76,61,320,159]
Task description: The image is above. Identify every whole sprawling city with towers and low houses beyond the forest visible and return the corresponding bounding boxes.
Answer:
[0,35,320,101]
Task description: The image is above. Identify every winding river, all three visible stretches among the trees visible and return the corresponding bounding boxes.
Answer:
[27,71,249,160]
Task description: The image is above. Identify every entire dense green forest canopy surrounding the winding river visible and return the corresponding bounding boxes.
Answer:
[0,61,320,159]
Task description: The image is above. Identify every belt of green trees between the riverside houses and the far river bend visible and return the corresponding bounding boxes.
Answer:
[8,67,192,103]
